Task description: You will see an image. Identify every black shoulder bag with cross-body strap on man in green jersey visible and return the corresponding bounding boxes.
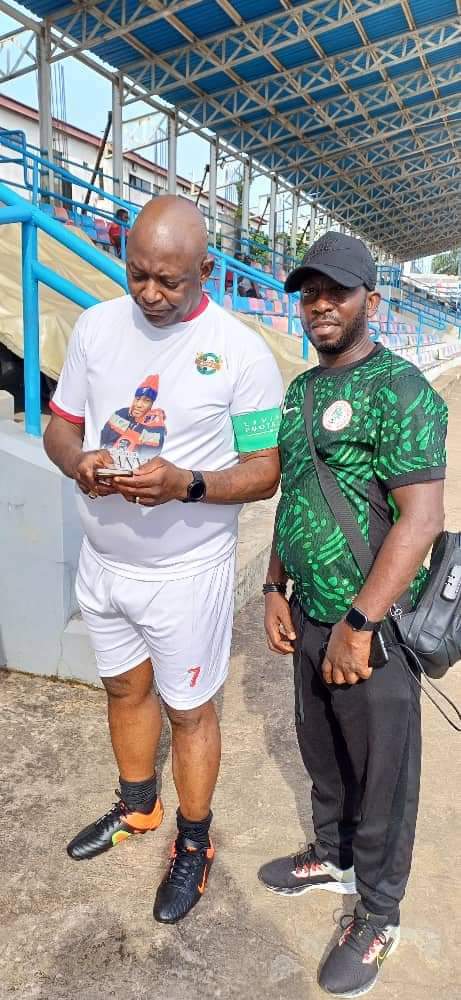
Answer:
[304,378,461,732]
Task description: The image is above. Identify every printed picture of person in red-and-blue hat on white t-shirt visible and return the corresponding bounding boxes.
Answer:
[100,375,166,467]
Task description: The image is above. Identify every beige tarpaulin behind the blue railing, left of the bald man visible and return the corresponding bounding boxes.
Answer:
[0,225,123,379]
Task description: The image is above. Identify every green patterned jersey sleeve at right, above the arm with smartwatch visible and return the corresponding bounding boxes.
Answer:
[374,372,448,490]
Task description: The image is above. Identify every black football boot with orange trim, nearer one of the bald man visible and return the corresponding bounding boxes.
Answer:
[154,833,215,924]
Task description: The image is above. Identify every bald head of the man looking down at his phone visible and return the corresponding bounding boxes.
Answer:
[127,195,213,327]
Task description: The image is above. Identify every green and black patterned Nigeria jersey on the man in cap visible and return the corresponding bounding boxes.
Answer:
[275,345,447,623]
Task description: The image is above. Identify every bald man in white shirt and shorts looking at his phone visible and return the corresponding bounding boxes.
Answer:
[45,196,283,923]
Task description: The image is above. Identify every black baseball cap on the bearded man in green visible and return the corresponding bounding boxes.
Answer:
[285,231,378,292]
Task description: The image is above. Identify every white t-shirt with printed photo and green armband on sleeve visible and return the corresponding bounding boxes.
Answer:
[51,296,283,580]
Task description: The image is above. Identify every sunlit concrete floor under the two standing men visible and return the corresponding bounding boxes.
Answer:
[0,383,461,1000]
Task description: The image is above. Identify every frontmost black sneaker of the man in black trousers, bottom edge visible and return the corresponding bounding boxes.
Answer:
[319,910,400,997]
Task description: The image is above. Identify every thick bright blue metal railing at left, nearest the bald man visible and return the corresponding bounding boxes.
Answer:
[0,184,127,436]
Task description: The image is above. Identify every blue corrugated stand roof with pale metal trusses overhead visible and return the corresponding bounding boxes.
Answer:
[18,0,461,257]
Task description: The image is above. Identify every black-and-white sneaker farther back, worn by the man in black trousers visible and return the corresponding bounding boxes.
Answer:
[258,844,357,896]
